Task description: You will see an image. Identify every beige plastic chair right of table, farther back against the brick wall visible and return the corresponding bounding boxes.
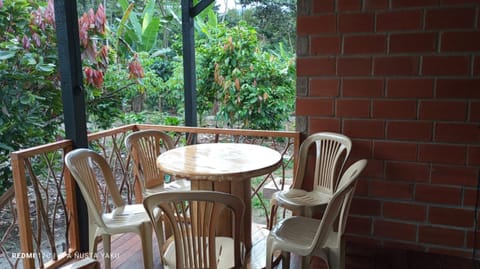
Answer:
[268,132,352,229]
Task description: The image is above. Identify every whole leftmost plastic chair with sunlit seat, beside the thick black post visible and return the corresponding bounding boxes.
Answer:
[65,149,153,268]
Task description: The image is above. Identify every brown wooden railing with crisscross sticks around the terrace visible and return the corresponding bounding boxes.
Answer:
[5,124,300,269]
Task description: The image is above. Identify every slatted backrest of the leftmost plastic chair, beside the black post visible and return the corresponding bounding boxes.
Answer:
[65,148,125,227]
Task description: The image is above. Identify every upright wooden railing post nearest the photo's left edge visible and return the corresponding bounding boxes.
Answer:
[10,153,35,269]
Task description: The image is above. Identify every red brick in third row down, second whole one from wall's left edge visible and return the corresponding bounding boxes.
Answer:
[343,35,387,54]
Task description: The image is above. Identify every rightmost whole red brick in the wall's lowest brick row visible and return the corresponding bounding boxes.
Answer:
[418,226,465,247]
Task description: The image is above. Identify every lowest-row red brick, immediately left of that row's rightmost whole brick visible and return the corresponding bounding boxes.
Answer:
[373,220,417,241]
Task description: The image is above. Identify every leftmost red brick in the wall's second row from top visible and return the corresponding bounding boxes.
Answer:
[297,14,337,36]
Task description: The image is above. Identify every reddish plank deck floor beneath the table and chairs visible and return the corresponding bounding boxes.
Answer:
[77,223,480,269]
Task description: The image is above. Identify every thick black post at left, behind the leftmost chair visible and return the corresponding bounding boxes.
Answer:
[54,0,88,252]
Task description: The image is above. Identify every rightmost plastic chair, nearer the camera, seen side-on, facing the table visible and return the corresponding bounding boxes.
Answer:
[266,159,367,269]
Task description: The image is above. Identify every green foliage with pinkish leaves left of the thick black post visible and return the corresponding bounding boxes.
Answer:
[0,0,62,194]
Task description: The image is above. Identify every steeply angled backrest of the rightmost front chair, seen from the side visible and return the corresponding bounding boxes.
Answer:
[311,159,367,252]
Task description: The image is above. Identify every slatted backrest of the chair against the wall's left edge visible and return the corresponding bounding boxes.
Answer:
[293,132,352,195]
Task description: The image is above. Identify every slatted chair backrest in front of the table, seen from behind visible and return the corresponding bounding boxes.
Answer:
[143,191,245,269]
